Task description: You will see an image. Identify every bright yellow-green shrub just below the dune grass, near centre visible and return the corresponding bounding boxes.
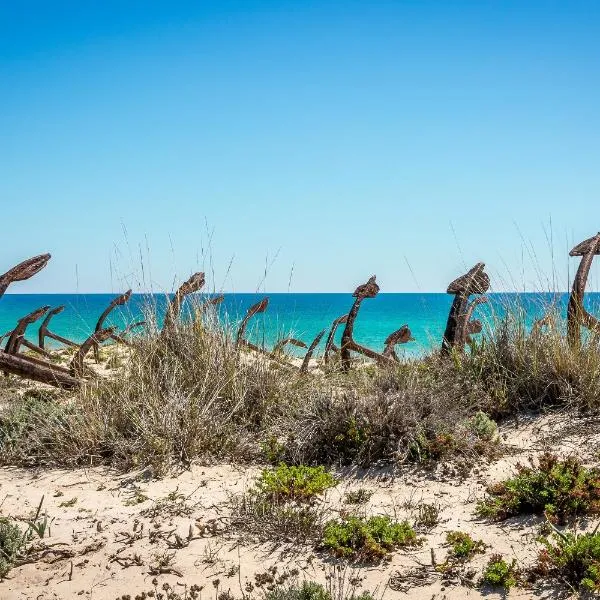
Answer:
[256,464,338,502]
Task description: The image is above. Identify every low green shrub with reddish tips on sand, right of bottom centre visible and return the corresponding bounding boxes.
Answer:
[322,516,420,561]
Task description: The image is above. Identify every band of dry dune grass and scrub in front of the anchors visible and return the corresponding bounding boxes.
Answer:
[0,315,600,474]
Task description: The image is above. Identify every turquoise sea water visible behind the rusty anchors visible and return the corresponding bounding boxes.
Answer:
[0,293,600,354]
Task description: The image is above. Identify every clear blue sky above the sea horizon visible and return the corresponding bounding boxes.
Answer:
[0,0,600,292]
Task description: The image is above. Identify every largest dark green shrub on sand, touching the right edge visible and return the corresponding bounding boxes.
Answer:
[477,453,600,523]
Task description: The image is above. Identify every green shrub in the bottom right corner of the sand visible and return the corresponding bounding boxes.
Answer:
[536,527,600,592]
